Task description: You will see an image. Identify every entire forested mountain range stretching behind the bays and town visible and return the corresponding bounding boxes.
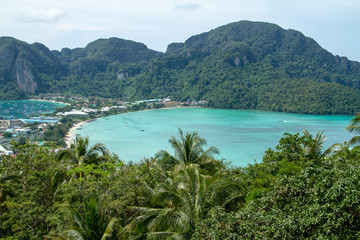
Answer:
[0,21,360,114]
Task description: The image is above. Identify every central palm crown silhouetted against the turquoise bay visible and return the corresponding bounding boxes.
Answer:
[157,128,222,170]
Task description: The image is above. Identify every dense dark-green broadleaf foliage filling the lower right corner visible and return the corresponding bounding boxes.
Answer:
[193,150,360,239]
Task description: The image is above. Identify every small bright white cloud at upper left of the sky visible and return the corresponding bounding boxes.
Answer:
[17,8,65,23]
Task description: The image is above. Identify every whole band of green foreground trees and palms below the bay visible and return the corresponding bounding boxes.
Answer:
[0,114,360,240]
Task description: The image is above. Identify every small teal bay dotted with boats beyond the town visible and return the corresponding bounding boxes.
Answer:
[0,100,65,119]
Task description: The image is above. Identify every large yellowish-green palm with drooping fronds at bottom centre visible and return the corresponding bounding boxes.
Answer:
[124,165,240,239]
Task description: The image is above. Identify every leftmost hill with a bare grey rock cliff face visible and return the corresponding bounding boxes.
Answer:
[0,37,62,94]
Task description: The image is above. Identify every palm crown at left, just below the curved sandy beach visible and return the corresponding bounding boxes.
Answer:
[57,134,109,166]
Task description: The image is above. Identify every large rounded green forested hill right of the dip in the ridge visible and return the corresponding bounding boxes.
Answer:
[123,22,360,114]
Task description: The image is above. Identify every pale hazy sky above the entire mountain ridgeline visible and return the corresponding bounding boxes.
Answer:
[0,0,360,61]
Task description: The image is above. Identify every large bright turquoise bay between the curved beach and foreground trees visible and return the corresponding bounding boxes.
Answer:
[73,108,352,166]
